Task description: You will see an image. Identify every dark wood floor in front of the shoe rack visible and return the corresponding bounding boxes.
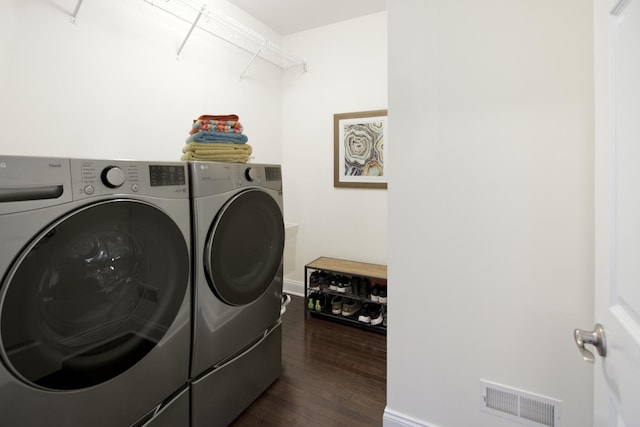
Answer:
[232,296,387,427]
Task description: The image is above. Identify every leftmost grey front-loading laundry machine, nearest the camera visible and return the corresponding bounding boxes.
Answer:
[0,156,191,427]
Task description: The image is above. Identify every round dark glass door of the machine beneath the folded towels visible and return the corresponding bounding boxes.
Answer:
[204,189,284,306]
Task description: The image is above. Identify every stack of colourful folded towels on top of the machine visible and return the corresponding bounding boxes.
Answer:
[181,114,252,163]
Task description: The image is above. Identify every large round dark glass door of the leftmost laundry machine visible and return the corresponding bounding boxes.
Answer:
[0,200,189,390]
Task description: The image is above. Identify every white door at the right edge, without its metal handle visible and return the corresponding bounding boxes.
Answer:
[586,0,640,427]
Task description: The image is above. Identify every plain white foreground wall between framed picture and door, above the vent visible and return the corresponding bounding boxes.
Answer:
[385,0,594,427]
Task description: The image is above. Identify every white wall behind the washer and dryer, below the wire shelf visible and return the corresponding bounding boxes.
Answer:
[0,0,282,163]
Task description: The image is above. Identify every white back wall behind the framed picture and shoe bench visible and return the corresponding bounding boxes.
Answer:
[283,12,393,290]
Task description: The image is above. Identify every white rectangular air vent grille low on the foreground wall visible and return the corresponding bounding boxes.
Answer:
[480,380,561,427]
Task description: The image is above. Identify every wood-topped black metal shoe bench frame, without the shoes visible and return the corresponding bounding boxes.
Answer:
[304,257,387,334]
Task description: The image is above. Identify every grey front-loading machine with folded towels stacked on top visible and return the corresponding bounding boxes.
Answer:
[189,162,284,427]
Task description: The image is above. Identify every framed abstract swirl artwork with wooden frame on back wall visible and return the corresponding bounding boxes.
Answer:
[333,110,387,188]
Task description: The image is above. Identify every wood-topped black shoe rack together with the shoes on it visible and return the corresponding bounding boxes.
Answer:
[304,257,387,335]
